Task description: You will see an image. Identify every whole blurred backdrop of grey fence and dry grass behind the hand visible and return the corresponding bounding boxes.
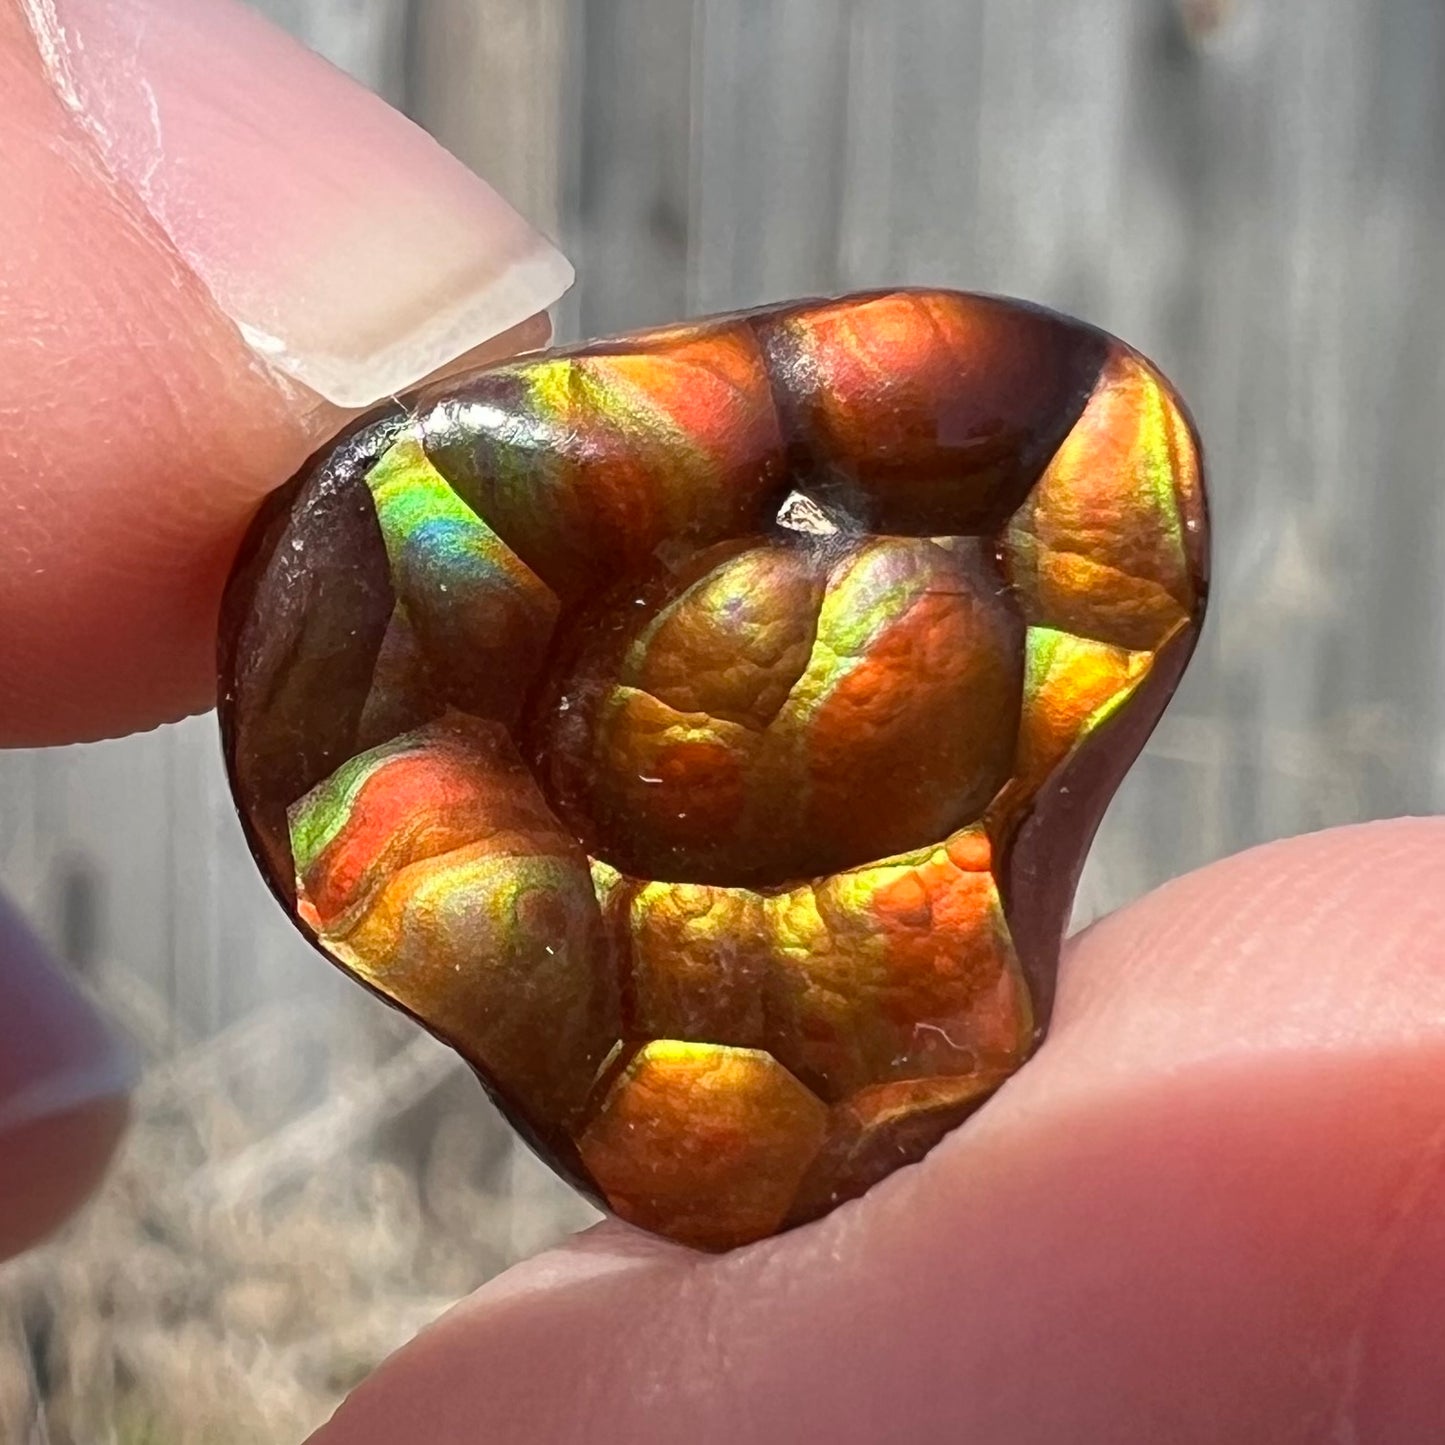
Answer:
[0,0,1445,1445]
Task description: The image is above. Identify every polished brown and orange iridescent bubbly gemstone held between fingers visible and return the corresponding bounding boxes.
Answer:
[221,292,1207,1248]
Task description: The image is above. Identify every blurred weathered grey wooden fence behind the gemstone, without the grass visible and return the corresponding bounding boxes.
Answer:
[0,0,1445,1040]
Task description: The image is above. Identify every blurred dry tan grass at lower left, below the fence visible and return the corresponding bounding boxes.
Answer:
[0,974,594,1445]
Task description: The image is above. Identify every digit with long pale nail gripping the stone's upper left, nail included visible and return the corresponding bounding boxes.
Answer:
[0,0,571,743]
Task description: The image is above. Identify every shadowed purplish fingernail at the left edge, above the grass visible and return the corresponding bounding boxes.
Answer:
[0,897,137,1138]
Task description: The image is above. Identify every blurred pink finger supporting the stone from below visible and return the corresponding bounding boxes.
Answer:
[307,819,1445,1445]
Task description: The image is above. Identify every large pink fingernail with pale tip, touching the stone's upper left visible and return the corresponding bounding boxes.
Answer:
[25,0,572,407]
